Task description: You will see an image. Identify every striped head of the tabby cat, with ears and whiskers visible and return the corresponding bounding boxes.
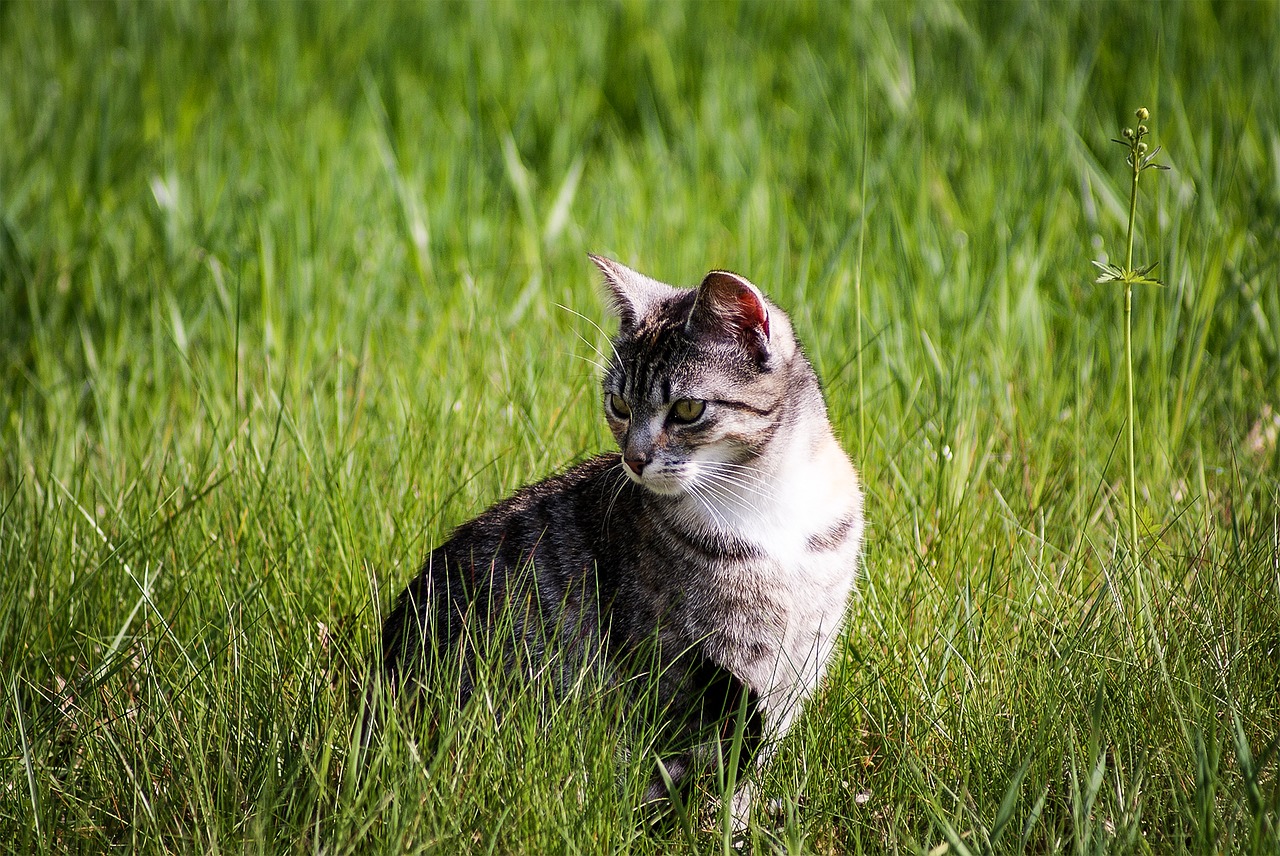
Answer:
[591,256,820,496]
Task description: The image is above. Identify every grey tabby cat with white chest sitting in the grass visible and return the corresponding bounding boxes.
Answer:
[381,255,863,828]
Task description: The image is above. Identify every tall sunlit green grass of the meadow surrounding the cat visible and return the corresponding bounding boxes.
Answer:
[0,0,1280,853]
